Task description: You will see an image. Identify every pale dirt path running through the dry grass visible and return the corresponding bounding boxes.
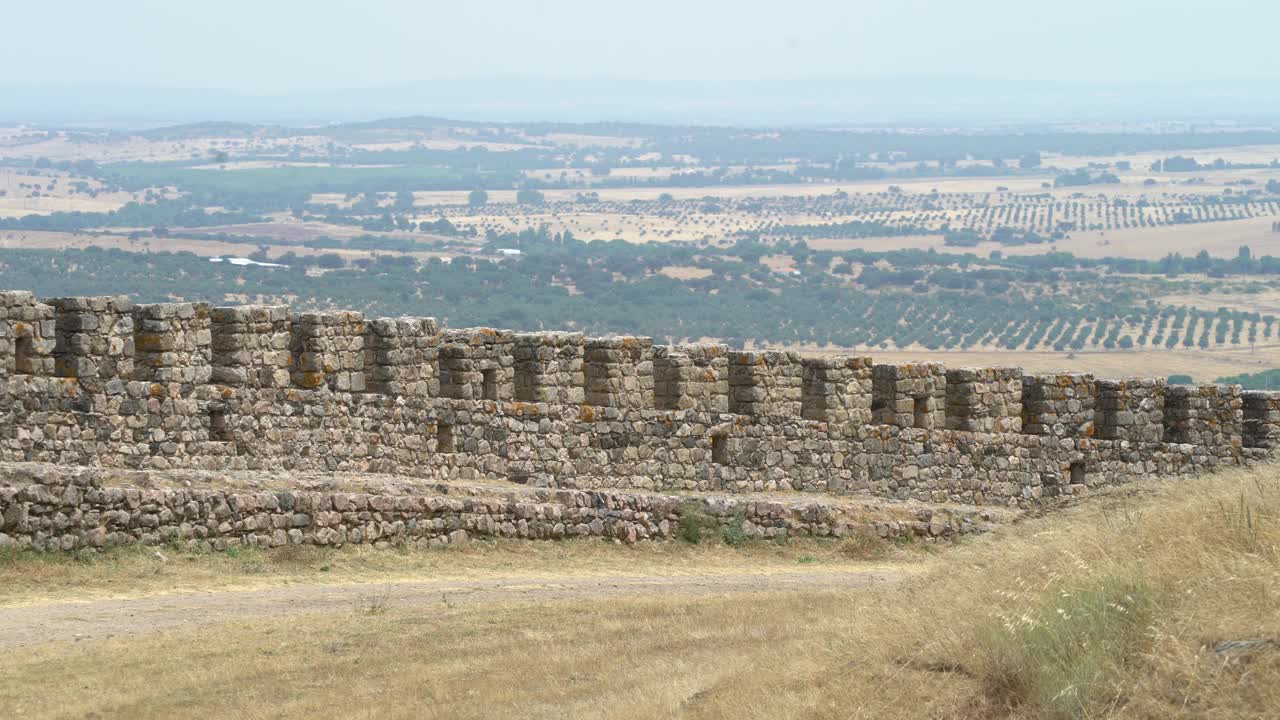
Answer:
[0,570,902,648]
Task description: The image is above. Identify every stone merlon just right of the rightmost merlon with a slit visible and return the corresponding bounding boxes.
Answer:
[946,368,1023,433]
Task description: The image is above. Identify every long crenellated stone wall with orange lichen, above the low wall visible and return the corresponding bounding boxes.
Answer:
[0,285,1280,505]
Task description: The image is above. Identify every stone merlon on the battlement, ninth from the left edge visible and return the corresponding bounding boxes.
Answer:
[582,336,654,407]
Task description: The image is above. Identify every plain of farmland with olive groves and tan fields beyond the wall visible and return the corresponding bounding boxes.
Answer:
[0,118,1280,379]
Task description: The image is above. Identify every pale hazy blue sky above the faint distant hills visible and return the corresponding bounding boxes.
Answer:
[0,0,1280,92]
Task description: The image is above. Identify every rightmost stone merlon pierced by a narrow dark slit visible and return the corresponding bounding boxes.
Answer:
[872,363,947,429]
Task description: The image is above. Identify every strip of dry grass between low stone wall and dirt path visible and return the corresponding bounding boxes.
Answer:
[0,539,923,607]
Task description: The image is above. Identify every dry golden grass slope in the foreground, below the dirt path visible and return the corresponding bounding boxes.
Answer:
[0,465,1280,720]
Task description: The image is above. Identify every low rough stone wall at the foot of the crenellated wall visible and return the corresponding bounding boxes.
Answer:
[0,464,1010,550]
